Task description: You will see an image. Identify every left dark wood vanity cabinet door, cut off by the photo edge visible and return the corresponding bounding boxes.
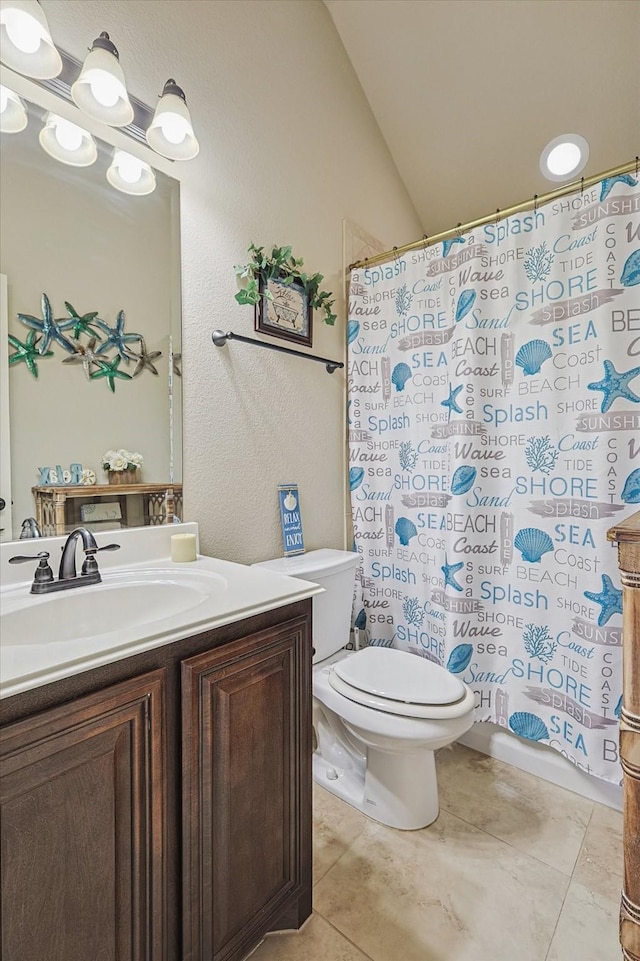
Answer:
[0,670,166,961]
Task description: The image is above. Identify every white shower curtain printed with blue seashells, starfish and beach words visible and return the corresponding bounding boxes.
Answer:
[348,174,640,783]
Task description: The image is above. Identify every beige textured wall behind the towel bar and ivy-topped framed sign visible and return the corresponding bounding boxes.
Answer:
[43,0,421,563]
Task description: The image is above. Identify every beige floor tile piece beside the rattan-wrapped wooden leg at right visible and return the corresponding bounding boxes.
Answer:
[573,804,624,902]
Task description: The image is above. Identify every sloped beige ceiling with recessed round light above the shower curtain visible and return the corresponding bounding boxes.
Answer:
[324,0,640,243]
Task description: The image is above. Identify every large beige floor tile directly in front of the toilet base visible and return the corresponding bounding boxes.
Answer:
[314,811,569,961]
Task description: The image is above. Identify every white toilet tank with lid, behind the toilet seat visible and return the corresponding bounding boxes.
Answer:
[255,548,359,663]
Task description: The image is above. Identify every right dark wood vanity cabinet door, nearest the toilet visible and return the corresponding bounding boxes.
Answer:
[182,617,311,961]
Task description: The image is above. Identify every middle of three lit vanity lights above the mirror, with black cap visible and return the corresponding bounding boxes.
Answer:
[71,31,133,127]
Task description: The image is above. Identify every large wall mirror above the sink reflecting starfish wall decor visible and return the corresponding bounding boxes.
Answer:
[0,98,182,540]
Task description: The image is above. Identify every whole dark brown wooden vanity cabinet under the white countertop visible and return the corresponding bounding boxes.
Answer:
[0,599,312,961]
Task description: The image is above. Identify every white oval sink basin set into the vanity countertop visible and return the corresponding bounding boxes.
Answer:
[2,570,227,646]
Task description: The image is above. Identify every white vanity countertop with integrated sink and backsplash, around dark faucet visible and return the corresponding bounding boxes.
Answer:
[0,524,322,697]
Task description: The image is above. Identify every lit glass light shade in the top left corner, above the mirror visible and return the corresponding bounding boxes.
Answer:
[0,0,62,80]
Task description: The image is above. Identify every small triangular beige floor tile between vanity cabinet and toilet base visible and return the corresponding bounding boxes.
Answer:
[313,783,368,884]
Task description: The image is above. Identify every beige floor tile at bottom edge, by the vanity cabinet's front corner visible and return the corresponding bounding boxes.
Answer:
[250,914,369,961]
